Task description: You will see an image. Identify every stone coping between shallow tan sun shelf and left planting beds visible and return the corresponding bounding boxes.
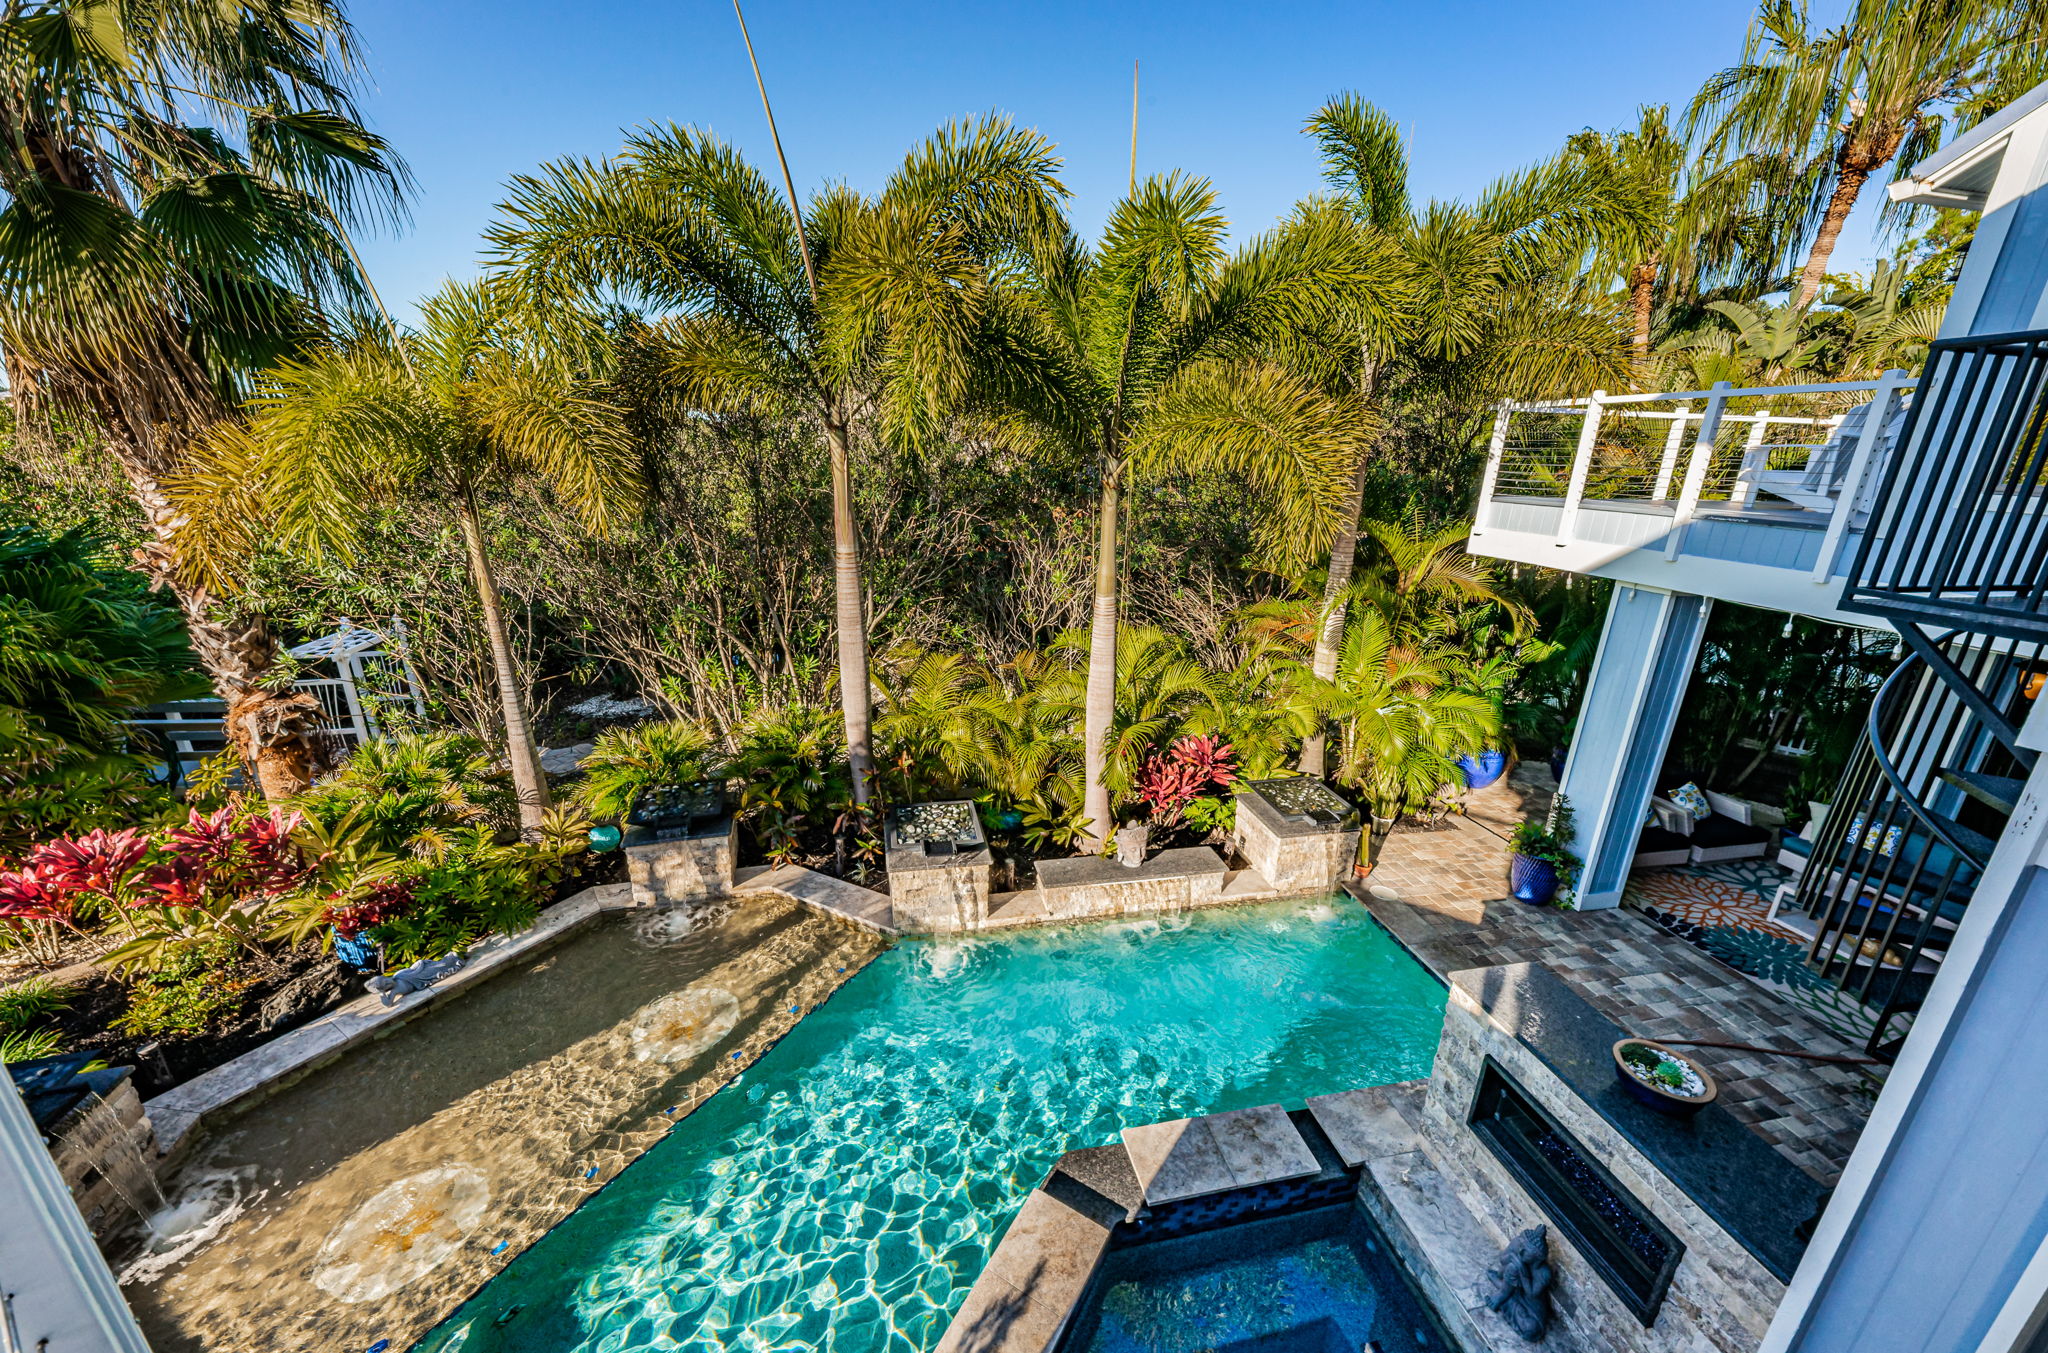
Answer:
[141,866,897,1171]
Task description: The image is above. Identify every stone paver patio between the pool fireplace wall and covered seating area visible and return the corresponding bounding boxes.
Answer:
[1360,763,1874,1183]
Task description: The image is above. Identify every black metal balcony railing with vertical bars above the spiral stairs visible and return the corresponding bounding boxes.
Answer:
[1843,330,2048,639]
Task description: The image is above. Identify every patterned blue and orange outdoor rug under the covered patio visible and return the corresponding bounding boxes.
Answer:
[1622,860,1903,1048]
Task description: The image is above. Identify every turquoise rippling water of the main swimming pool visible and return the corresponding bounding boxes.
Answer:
[418,899,1444,1353]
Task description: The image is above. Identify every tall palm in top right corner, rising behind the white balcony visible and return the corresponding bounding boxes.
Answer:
[1686,0,2048,309]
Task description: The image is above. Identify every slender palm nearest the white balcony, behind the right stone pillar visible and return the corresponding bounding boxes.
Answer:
[1288,94,1649,776]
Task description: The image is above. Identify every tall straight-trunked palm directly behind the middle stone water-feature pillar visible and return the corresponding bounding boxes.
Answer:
[487,117,1065,804]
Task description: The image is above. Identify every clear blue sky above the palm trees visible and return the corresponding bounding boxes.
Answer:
[352,0,1878,309]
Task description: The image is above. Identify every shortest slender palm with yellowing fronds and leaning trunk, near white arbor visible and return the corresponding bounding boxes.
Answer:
[176,282,635,833]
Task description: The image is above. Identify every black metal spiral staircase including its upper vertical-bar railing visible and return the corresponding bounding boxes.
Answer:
[1794,330,2048,1060]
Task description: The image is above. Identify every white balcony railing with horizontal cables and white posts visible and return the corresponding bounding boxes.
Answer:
[1475,370,1915,581]
